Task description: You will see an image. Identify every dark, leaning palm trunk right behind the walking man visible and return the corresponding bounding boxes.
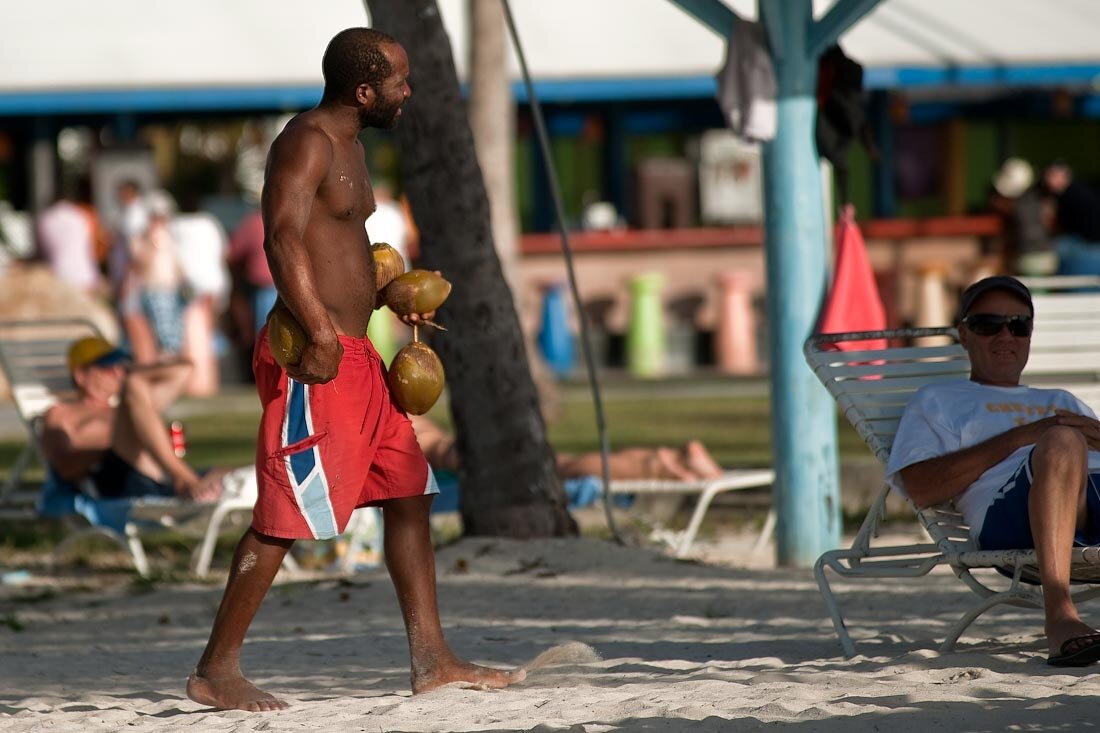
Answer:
[367,0,576,538]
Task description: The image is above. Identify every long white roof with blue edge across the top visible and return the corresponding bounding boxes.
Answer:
[0,0,1100,114]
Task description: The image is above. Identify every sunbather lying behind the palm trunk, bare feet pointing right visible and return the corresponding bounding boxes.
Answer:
[409,415,723,481]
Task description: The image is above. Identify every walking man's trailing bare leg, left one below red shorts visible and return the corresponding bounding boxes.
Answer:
[187,528,294,712]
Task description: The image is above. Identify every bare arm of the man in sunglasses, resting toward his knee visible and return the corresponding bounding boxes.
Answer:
[899,412,1100,508]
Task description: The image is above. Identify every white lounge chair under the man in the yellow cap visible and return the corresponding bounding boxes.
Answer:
[0,318,275,576]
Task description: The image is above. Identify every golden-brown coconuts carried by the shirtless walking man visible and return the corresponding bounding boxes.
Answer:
[267,242,451,415]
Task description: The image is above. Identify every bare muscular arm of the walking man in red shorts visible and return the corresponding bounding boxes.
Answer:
[262,125,342,383]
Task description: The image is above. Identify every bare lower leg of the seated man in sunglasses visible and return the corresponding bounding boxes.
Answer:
[1027,427,1096,654]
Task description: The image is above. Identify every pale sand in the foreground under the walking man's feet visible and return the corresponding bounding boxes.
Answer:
[0,530,1100,733]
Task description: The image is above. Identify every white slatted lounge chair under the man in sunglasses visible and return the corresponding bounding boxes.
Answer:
[804,327,1100,657]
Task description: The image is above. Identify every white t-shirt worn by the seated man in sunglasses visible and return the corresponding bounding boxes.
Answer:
[887,380,1100,537]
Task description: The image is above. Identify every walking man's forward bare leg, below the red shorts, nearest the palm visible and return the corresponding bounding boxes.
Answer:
[382,496,526,693]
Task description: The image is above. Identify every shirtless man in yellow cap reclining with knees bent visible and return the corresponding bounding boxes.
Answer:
[42,337,221,501]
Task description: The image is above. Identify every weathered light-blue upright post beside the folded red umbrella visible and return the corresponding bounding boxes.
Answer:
[759,0,840,567]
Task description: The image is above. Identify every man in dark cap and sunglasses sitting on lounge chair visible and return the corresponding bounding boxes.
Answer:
[887,275,1100,666]
